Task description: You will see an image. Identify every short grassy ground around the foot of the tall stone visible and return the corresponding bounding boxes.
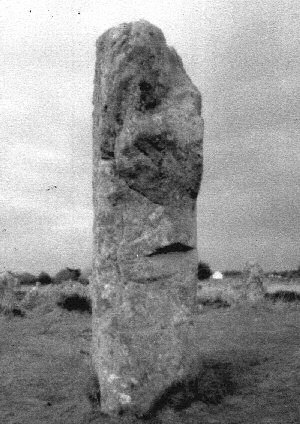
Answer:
[0,281,300,424]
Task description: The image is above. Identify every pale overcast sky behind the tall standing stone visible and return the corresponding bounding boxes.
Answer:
[0,0,300,273]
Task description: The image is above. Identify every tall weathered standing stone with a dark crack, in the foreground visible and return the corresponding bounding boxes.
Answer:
[91,21,203,414]
